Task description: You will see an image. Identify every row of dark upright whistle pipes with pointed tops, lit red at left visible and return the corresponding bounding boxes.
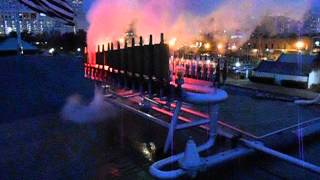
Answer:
[85,33,170,95]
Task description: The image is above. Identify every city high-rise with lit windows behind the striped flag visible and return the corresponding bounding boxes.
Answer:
[0,0,87,35]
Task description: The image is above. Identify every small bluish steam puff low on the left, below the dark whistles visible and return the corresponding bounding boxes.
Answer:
[61,89,117,124]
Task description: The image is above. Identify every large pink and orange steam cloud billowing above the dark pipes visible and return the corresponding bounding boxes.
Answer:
[87,0,311,63]
